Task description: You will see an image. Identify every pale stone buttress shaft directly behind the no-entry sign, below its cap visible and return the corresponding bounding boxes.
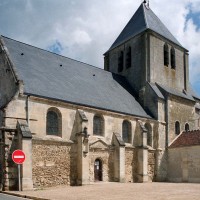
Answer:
[21,138,33,191]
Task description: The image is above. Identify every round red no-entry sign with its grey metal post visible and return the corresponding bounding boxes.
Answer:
[12,150,26,191]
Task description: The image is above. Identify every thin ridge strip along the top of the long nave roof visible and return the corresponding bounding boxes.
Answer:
[0,35,109,72]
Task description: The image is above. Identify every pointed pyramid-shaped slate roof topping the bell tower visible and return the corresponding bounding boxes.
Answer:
[109,3,182,50]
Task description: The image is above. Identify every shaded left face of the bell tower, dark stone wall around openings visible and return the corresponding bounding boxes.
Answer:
[105,34,146,91]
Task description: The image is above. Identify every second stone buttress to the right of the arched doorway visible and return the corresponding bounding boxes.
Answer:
[138,122,148,183]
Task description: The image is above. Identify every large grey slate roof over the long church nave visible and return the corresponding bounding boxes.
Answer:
[1,36,150,118]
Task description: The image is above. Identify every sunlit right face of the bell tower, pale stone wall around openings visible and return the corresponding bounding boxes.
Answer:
[150,34,187,91]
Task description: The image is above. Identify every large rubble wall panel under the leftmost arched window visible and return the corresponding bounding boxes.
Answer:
[32,139,71,188]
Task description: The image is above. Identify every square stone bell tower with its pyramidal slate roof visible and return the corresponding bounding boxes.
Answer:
[104,1,189,95]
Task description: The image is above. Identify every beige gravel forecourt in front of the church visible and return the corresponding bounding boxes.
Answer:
[3,183,200,200]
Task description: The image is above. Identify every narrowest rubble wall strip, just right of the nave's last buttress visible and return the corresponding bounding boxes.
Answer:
[148,150,155,181]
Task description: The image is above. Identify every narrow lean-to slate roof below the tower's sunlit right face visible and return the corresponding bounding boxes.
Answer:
[156,83,195,101]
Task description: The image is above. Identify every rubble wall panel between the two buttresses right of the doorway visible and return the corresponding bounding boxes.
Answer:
[125,147,137,183]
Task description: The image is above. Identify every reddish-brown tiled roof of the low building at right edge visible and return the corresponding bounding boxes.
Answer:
[169,130,200,148]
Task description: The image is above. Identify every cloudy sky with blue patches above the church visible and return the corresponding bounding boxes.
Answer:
[0,0,200,95]
